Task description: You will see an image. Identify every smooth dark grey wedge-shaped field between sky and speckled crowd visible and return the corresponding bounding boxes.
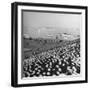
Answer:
[23,38,79,58]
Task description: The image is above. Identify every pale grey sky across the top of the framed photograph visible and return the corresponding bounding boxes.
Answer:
[22,11,81,38]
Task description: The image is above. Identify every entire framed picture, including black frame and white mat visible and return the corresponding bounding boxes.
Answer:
[13,3,87,86]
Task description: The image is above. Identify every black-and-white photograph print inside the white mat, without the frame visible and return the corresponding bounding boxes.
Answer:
[22,11,81,78]
